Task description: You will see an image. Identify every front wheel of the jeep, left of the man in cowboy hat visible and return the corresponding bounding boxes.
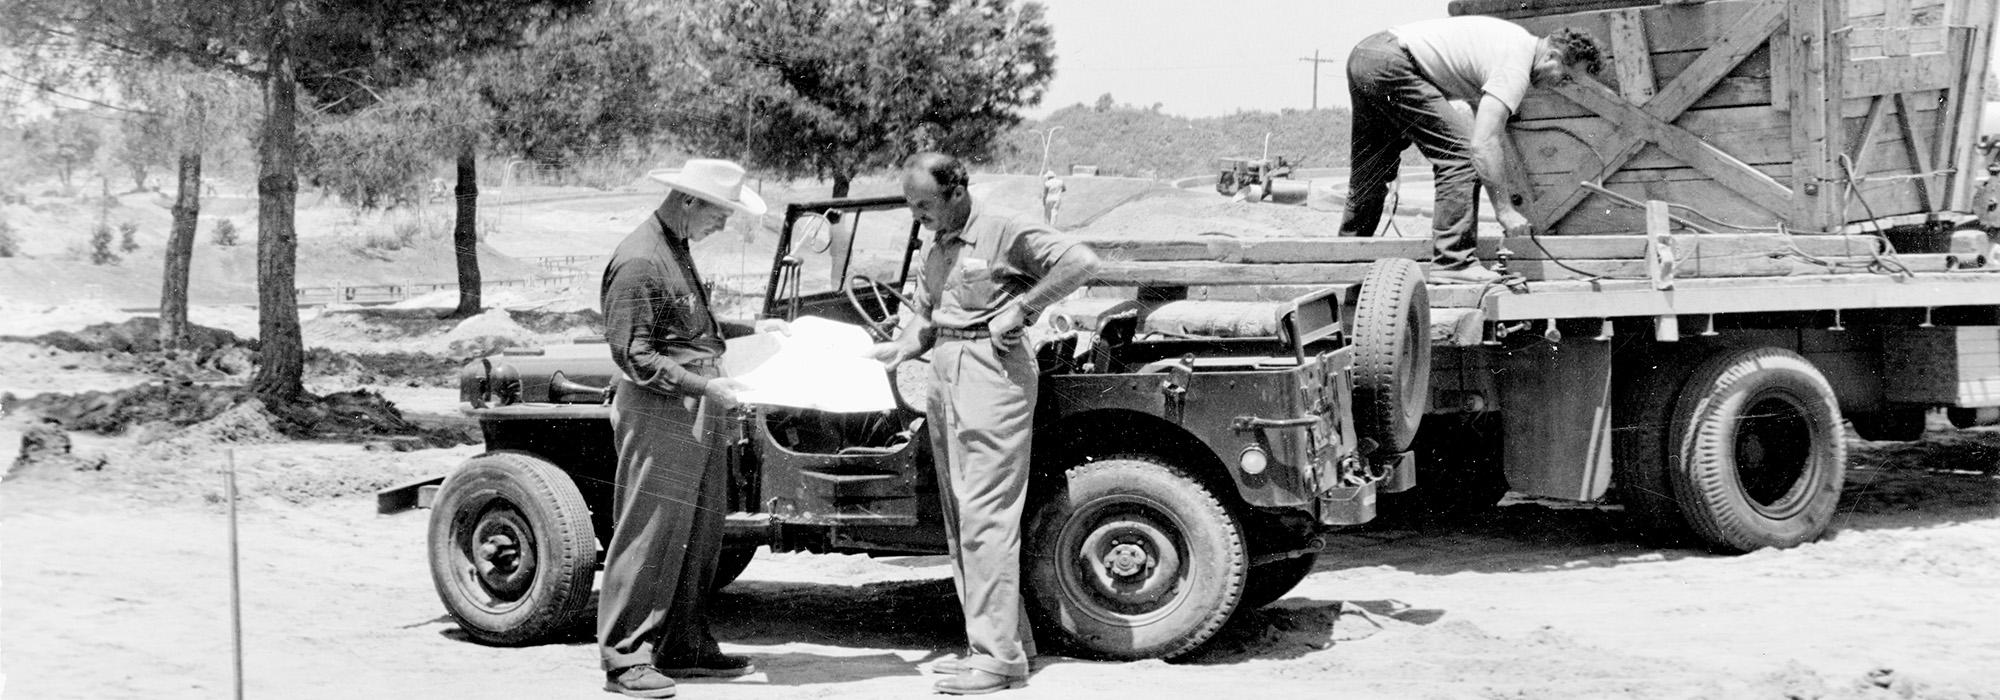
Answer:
[430,452,598,644]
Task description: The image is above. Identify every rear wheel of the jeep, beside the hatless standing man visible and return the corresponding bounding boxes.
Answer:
[1022,456,1250,660]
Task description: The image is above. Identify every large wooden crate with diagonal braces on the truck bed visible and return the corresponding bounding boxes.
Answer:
[1456,0,1996,238]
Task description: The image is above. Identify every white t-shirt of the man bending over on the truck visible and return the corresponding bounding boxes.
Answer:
[1388,16,1540,112]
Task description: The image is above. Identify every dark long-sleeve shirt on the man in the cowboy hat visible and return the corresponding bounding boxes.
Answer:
[600,212,722,396]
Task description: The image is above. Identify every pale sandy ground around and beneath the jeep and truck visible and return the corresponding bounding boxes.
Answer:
[0,176,2000,700]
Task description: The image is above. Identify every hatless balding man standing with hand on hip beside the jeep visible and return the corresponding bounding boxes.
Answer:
[874,152,1098,696]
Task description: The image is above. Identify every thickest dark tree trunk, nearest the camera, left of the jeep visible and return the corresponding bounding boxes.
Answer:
[250,0,306,400]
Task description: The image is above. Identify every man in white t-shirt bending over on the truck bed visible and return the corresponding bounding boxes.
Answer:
[1340,16,1602,284]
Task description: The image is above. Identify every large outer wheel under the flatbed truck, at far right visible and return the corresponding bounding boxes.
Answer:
[1668,348,1848,552]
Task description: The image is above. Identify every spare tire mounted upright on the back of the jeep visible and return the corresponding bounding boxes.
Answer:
[1352,258,1430,454]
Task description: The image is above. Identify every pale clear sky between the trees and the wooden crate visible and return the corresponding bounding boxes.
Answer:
[1028,0,1450,118]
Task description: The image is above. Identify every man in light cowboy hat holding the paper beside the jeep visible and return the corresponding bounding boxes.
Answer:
[598,158,764,698]
